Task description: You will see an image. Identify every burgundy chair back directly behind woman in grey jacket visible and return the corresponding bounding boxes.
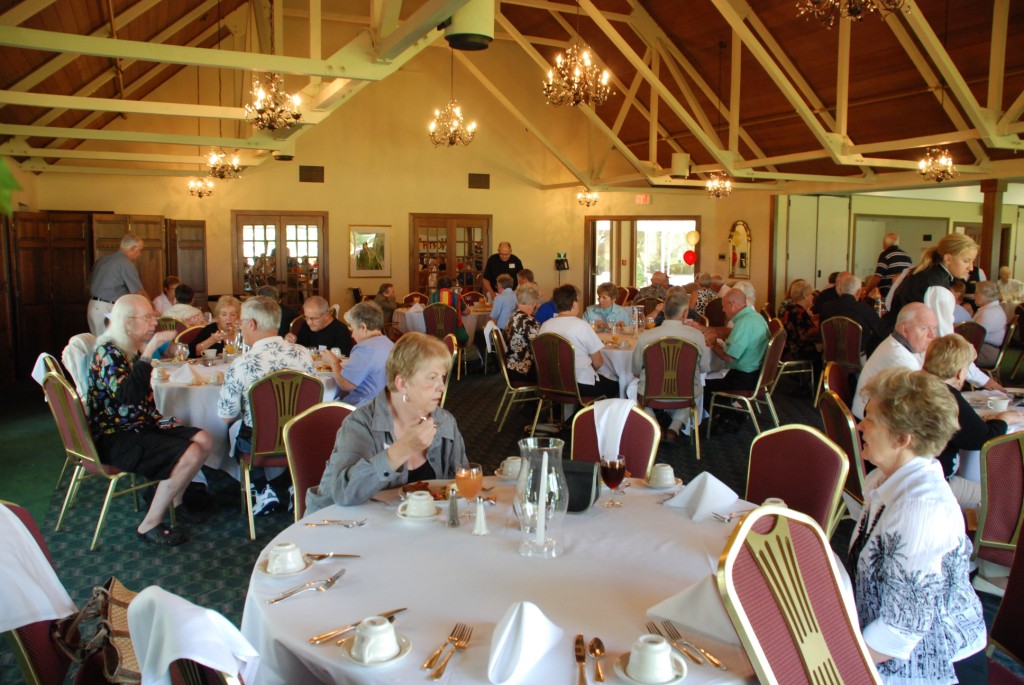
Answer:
[284,402,355,521]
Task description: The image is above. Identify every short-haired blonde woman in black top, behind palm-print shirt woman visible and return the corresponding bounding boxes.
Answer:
[925,333,1024,509]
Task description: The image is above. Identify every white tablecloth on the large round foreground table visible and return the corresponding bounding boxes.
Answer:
[242,478,753,685]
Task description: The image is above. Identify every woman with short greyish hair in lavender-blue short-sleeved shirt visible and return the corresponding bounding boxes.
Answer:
[321,302,394,406]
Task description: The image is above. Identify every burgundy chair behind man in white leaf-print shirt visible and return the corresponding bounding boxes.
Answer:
[239,369,324,540]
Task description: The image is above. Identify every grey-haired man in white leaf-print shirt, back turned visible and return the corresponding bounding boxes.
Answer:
[217,295,316,516]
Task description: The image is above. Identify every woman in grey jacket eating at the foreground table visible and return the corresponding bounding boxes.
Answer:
[306,333,466,511]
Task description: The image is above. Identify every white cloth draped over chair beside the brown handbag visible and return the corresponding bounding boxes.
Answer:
[128,586,259,685]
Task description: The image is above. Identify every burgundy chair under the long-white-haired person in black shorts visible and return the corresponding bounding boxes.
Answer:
[43,374,164,552]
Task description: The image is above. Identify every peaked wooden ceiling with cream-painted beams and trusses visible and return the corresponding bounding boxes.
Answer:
[0,0,1024,192]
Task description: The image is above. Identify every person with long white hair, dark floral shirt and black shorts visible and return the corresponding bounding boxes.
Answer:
[88,295,212,546]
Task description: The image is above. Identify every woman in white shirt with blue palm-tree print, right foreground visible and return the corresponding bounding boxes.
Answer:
[848,362,986,685]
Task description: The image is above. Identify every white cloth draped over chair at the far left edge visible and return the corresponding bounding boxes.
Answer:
[0,505,75,633]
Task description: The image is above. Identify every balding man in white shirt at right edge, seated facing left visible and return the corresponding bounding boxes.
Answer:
[850,302,939,419]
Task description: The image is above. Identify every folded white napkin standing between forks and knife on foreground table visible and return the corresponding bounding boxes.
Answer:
[487,602,563,685]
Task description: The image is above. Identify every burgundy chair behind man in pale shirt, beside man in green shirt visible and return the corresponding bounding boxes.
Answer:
[637,338,702,461]
